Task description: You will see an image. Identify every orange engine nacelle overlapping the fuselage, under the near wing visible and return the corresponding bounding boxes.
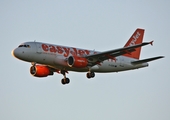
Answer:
[67,56,88,68]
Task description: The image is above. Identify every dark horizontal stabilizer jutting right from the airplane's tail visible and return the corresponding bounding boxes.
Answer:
[131,56,164,65]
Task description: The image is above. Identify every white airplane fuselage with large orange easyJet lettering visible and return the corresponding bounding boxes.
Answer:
[12,42,148,72]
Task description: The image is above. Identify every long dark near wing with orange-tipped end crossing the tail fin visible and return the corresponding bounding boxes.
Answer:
[85,41,153,66]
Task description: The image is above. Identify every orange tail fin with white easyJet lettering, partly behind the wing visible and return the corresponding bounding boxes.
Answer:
[124,28,145,59]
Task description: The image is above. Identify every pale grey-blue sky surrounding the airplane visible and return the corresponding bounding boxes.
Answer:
[0,0,170,120]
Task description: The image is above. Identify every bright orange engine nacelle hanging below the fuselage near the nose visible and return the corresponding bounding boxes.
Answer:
[30,65,53,77]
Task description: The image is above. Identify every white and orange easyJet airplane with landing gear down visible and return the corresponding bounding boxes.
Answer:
[12,28,164,85]
